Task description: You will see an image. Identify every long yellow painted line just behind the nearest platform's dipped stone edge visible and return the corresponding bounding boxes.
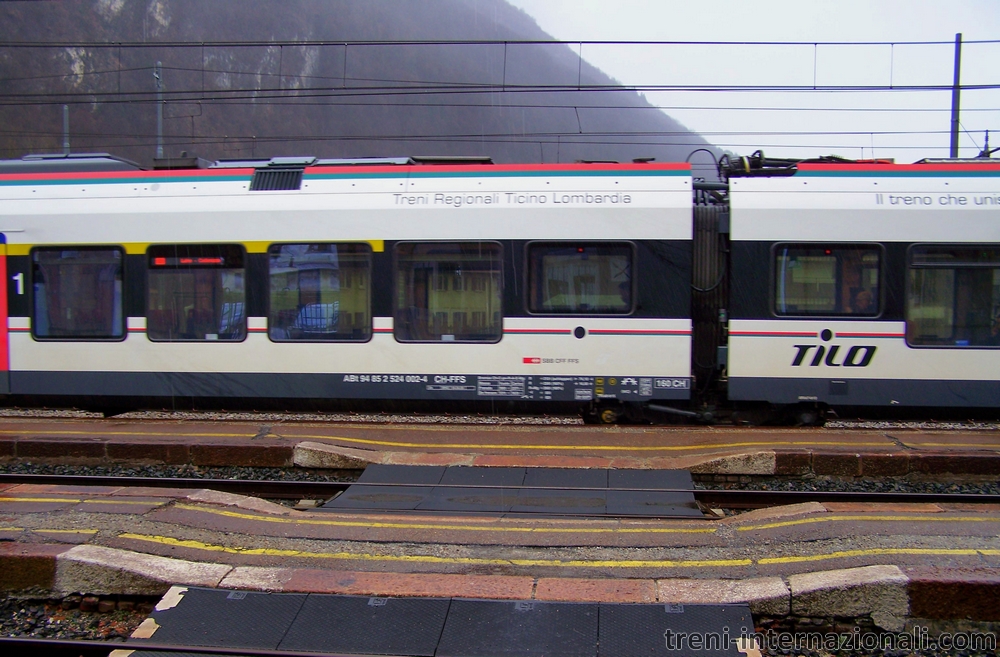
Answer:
[118,533,751,568]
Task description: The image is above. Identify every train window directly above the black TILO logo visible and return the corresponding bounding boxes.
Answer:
[774,244,882,317]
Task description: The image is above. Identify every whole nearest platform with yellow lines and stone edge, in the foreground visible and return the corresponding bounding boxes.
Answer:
[0,485,1000,630]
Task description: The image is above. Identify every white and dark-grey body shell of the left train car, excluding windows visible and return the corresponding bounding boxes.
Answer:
[0,163,691,402]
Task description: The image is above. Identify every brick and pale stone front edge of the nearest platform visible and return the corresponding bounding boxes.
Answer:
[0,543,1000,631]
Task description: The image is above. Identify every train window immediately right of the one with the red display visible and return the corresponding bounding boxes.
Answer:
[267,244,372,341]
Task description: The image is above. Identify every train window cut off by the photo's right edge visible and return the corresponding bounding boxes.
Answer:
[906,245,1000,347]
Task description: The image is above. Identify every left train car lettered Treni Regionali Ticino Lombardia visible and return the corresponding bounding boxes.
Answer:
[0,155,692,421]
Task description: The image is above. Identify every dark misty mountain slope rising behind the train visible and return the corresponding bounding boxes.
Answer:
[0,0,706,164]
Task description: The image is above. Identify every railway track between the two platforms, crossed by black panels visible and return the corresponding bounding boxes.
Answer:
[0,474,1000,509]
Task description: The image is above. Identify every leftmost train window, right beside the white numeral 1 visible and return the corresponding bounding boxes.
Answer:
[31,247,125,340]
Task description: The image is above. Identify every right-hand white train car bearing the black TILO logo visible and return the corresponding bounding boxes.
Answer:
[726,160,1000,418]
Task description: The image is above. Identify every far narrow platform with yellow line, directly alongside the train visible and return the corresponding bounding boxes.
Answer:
[0,418,1000,477]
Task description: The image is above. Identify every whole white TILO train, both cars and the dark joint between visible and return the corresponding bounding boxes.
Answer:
[0,152,1000,424]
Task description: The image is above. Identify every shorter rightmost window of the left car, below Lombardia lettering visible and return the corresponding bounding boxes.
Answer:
[527,242,635,315]
